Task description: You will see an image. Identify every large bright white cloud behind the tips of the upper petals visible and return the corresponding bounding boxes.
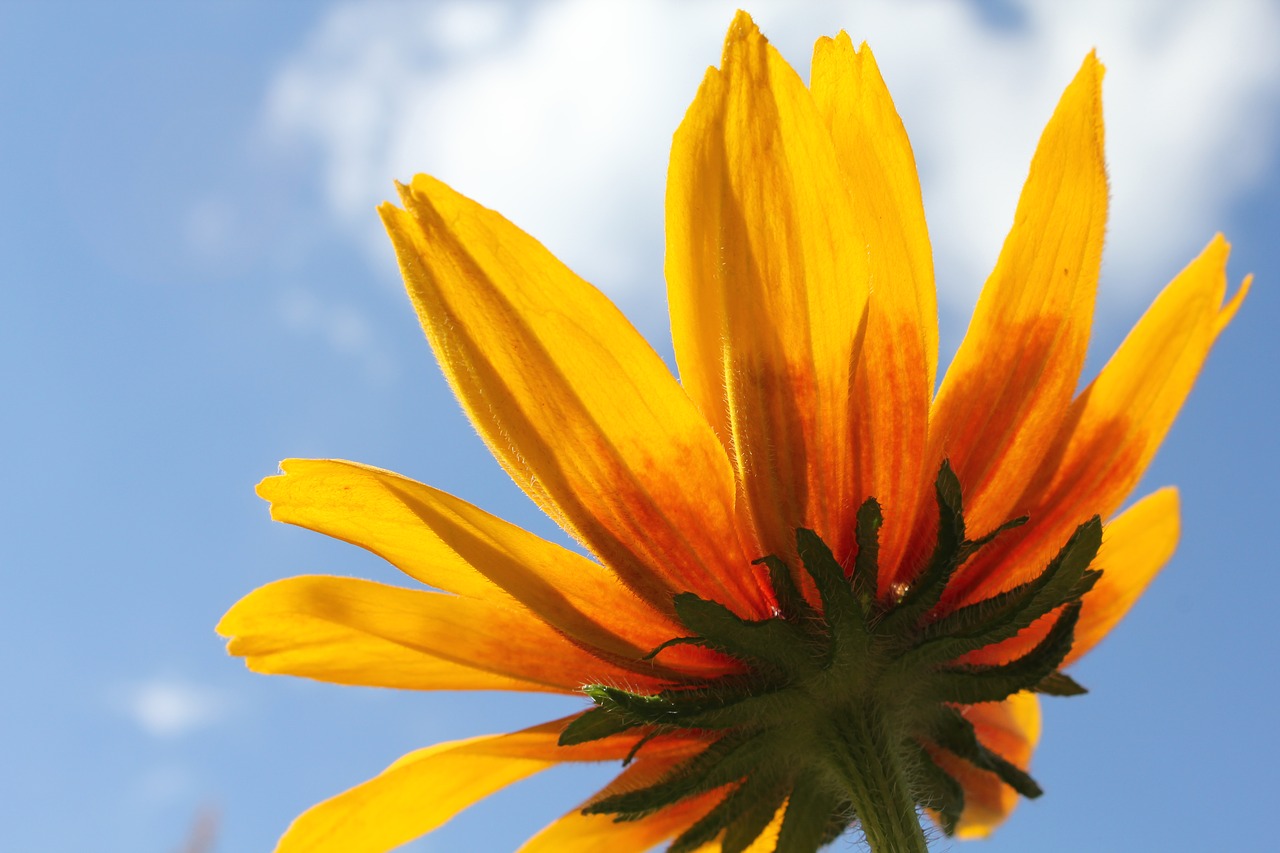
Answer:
[265,0,1280,312]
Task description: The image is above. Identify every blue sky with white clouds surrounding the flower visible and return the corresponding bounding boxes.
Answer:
[0,0,1280,853]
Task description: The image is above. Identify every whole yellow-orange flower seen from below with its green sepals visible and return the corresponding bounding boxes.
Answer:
[219,13,1248,852]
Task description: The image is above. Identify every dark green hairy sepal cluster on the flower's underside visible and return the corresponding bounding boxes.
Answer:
[559,462,1102,853]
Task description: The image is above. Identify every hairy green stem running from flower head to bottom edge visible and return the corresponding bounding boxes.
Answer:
[829,706,928,853]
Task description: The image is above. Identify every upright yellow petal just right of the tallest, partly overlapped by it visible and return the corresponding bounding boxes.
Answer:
[810,32,938,578]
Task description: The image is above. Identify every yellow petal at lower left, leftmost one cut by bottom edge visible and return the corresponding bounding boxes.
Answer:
[276,720,636,853]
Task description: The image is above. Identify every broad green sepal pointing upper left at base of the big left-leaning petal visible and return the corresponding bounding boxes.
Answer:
[675,593,815,675]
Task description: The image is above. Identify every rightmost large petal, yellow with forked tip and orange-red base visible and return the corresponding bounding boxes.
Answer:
[948,236,1251,601]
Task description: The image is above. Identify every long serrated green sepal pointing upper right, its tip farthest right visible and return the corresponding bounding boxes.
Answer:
[899,516,1102,669]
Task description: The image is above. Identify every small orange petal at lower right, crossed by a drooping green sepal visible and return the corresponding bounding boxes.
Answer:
[933,693,1041,839]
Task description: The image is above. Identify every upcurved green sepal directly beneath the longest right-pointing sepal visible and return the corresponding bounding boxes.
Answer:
[928,601,1080,704]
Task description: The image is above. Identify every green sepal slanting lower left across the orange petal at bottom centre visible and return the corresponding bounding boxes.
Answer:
[582,731,767,821]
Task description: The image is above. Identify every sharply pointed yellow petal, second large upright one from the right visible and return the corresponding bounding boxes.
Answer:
[923,54,1107,558]
